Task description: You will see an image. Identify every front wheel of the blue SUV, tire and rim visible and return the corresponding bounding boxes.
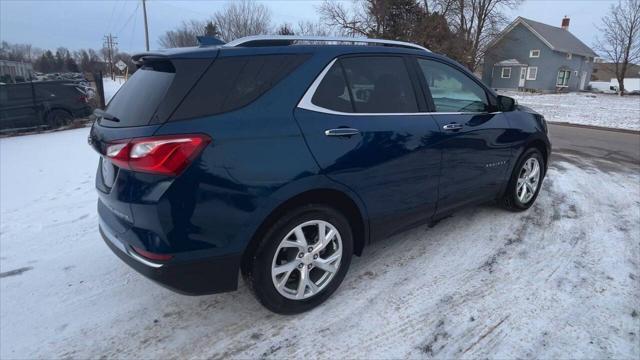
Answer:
[501,148,546,211]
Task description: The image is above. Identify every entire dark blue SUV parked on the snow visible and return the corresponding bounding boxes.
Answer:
[89,36,551,314]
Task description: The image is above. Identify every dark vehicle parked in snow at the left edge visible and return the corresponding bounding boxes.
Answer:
[0,81,92,132]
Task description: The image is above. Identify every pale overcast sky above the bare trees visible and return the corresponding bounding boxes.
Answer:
[0,0,615,52]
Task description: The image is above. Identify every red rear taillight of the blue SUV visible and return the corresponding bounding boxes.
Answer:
[105,134,211,176]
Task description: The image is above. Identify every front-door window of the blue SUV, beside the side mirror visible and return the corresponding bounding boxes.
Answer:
[418,59,489,112]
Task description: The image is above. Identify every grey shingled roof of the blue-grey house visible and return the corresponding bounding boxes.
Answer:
[491,16,598,57]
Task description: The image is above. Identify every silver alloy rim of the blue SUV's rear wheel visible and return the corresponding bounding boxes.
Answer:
[271,220,342,300]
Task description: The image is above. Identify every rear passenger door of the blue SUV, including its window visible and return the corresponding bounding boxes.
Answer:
[295,55,440,238]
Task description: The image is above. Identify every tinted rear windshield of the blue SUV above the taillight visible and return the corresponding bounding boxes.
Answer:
[100,67,175,127]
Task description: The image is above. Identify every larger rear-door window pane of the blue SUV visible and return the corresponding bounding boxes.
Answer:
[340,56,419,113]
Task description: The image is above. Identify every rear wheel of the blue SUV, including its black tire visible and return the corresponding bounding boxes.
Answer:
[243,204,353,314]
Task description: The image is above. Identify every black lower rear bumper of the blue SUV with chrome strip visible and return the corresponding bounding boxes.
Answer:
[100,226,241,295]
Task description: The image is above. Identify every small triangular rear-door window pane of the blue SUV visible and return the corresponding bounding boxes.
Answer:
[311,61,353,113]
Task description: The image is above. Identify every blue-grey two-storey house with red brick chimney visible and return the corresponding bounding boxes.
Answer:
[482,17,597,92]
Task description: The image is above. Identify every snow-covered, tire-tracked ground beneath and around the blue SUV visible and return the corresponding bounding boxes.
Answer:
[0,128,640,359]
